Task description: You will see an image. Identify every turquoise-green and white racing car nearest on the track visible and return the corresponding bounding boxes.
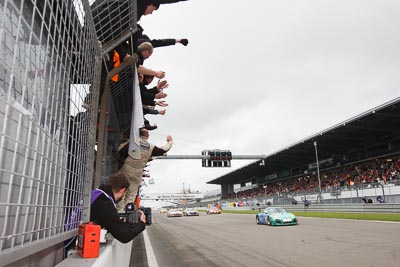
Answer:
[256,207,297,226]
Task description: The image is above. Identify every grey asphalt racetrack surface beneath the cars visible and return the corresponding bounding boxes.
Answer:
[146,212,400,267]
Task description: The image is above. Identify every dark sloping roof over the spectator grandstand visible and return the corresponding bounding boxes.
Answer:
[207,97,400,184]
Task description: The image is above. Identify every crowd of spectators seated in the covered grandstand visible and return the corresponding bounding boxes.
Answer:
[227,157,400,199]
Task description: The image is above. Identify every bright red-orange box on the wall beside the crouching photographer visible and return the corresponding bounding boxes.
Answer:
[78,222,101,258]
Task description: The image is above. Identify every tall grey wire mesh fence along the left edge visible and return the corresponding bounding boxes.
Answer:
[0,0,101,265]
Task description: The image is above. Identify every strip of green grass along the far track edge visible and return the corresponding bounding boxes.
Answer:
[199,210,400,222]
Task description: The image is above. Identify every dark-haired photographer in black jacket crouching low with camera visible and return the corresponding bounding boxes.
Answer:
[90,172,146,243]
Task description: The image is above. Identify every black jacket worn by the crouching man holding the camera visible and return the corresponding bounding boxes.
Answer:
[90,184,146,243]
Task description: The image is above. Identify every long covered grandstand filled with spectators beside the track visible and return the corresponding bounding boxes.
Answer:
[208,98,400,203]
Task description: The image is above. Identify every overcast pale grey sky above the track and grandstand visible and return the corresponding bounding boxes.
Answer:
[135,0,400,201]
